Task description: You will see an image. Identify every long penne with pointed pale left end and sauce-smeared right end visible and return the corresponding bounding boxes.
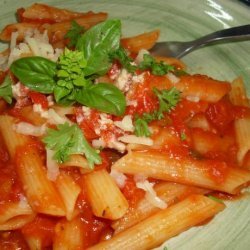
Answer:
[113,151,250,194]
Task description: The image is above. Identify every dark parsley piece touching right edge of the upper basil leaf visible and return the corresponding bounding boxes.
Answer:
[110,47,137,73]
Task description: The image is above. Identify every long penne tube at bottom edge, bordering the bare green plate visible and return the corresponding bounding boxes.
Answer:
[88,195,225,250]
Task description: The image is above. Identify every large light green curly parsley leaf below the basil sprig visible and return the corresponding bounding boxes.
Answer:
[43,123,101,168]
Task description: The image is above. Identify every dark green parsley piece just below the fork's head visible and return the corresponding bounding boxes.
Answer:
[139,54,175,76]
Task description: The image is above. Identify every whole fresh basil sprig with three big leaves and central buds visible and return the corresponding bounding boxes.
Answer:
[10,20,126,116]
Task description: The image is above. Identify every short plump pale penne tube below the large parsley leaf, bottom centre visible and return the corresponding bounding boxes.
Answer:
[84,170,128,220]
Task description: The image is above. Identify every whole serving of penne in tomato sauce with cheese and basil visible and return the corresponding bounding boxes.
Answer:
[0,4,250,250]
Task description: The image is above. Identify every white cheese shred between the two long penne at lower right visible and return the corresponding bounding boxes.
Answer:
[136,180,167,209]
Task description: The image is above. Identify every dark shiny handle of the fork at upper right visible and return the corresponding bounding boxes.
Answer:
[195,24,250,48]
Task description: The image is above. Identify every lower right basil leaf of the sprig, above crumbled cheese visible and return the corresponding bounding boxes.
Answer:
[75,83,126,116]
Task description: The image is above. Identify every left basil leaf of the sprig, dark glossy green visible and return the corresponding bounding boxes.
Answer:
[10,56,56,94]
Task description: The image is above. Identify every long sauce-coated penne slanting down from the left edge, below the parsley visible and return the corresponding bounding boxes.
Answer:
[0,116,65,216]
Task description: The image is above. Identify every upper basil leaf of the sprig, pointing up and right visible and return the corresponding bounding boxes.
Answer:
[76,20,121,76]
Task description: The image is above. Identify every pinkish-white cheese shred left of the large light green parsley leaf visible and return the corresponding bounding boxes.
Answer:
[13,122,47,136]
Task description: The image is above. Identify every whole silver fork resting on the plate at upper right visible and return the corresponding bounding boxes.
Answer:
[150,24,250,58]
